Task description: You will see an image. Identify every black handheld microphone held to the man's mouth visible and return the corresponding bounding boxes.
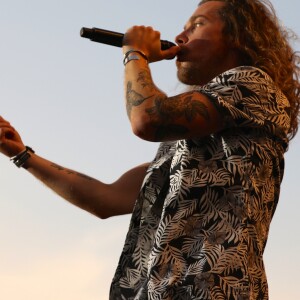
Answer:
[80,27,176,50]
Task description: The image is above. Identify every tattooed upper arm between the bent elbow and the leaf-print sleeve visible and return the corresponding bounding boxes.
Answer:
[131,91,223,141]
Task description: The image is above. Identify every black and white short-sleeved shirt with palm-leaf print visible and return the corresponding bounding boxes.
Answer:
[110,67,290,300]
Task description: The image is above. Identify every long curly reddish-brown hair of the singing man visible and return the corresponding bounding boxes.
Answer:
[199,0,300,140]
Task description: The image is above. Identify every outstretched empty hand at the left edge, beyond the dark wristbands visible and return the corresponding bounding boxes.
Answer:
[0,116,25,157]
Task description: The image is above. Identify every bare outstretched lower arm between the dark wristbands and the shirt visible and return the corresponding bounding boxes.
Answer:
[21,154,146,218]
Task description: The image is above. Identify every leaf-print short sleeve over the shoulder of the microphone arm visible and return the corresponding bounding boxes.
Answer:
[200,66,290,142]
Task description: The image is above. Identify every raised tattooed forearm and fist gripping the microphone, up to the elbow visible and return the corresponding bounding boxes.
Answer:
[123,26,180,141]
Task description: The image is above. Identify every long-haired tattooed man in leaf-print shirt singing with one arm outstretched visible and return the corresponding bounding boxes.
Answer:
[0,0,300,300]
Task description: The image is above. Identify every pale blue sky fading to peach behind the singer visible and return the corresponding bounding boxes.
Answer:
[0,0,300,300]
